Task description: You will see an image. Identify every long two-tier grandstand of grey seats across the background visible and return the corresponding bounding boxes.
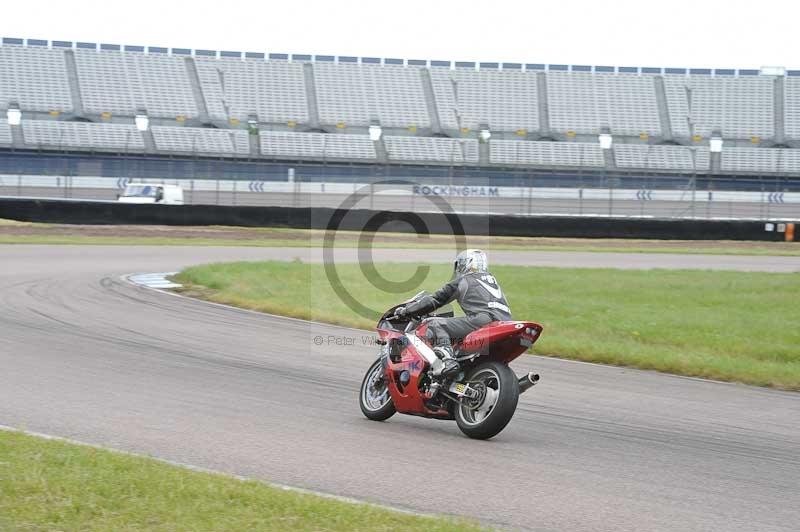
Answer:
[0,38,800,182]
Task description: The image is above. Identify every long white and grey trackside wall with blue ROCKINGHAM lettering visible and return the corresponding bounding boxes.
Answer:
[0,175,800,220]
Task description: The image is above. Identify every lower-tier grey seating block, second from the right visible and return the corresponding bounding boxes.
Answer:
[614,144,711,172]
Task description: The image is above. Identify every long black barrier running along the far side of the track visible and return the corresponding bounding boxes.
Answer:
[0,198,786,241]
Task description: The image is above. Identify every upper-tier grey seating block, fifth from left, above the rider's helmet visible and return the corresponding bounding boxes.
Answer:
[431,68,539,131]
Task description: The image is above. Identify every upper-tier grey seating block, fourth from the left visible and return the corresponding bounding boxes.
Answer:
[314,63,430,128]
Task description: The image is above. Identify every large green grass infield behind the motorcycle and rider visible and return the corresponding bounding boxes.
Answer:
[177,262,800,390]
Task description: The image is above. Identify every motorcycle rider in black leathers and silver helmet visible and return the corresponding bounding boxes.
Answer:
[395,249,512,375]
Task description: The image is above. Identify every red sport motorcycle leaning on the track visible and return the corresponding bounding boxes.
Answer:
[359,292,542,440]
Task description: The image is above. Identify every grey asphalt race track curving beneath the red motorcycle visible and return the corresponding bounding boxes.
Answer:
[0,246,800,532]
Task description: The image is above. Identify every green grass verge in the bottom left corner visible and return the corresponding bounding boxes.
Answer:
[0,430,479,532]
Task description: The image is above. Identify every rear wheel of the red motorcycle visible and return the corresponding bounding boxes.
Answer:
[455,362,519,440]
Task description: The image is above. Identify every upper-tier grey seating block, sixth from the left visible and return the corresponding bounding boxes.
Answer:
[547,72,661,135]
